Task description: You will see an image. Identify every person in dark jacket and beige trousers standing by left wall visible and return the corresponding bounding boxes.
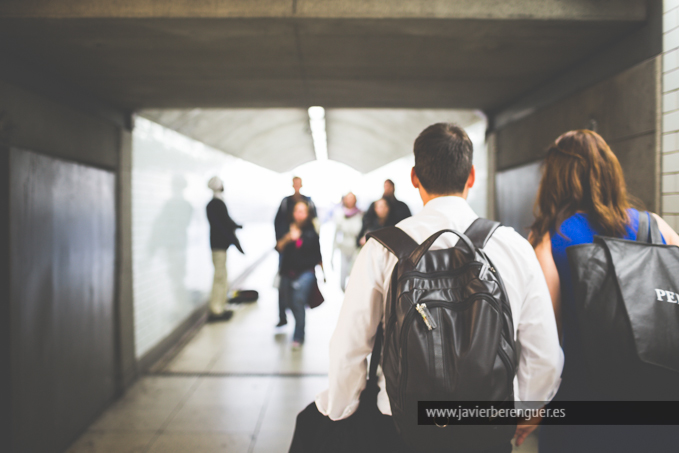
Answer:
[206,176,243,321]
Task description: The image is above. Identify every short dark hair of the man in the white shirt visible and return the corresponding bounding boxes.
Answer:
[414,123,474,195]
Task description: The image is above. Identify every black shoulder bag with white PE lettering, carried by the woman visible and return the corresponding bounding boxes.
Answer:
[566,212,679,401]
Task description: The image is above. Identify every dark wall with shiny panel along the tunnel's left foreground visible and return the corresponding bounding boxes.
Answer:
[0,69,135,452]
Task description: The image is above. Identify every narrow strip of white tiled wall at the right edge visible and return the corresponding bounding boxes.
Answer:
[661,0,679,230]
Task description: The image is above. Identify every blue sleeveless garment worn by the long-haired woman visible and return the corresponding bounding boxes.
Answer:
[550,209,665,400]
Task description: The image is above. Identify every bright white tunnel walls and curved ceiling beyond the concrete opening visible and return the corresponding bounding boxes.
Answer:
[131,109,487,363]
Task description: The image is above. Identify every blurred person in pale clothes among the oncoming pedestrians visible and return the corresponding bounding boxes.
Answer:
[333,192,363,291]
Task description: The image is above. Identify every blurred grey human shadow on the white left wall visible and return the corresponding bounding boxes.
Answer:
[148,175,196,321]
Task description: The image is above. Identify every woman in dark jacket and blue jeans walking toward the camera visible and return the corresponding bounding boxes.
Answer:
[276,201,322,349]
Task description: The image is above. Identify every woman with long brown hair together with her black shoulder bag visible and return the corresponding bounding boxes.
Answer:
[529,130,679,453]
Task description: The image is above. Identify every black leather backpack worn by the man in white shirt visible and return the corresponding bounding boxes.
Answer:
[368,218,517,452]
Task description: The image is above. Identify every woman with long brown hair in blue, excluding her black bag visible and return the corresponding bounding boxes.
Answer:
[529,130,679,453]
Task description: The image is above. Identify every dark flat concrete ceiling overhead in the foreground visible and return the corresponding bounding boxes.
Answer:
[0,0,646,110]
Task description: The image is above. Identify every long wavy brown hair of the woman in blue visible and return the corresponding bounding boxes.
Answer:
[530,130,636,247]
